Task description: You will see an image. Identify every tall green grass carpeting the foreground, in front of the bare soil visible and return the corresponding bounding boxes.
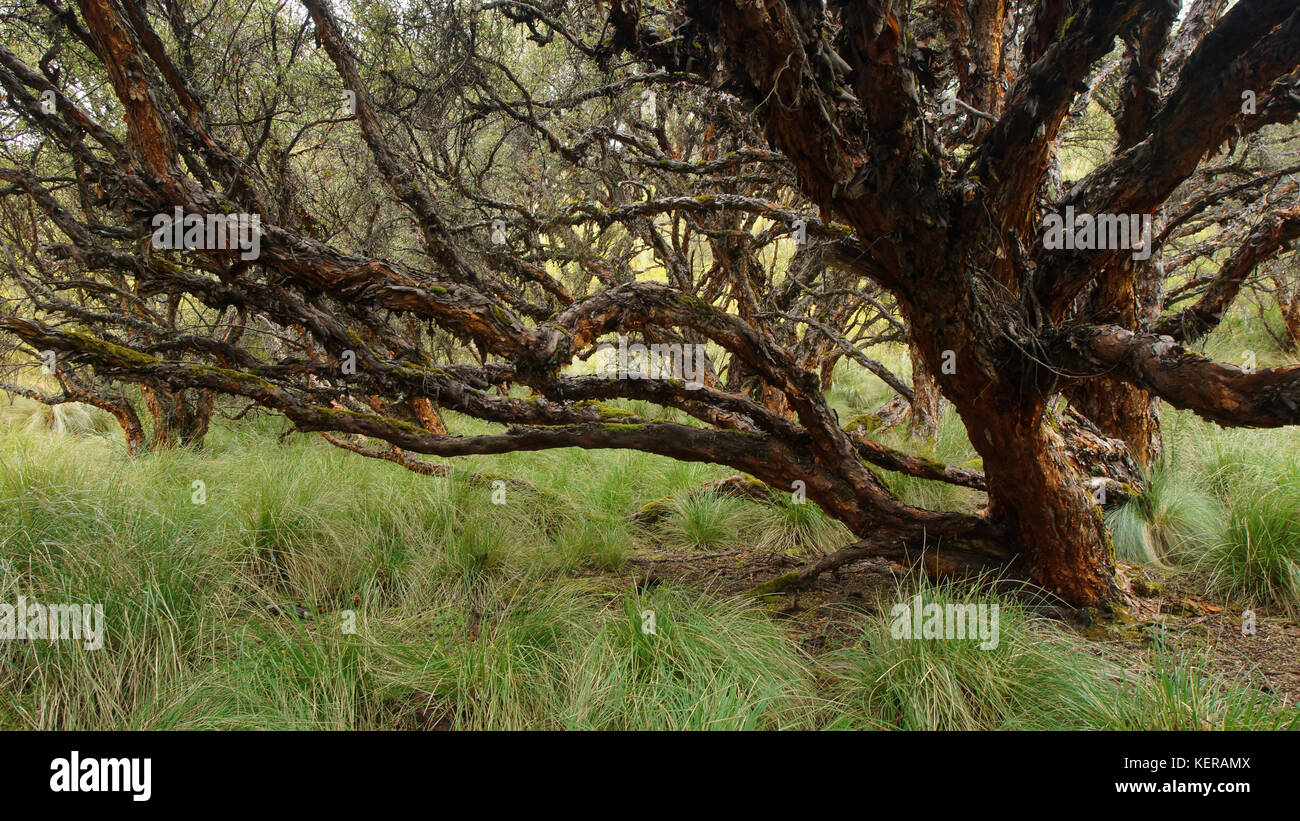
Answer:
[0,422,1292,729]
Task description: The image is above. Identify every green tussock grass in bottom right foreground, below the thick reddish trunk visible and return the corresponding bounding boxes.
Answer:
[820,583,1300,730]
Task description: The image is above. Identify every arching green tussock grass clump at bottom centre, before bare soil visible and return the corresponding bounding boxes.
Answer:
[364,583,819,730]
